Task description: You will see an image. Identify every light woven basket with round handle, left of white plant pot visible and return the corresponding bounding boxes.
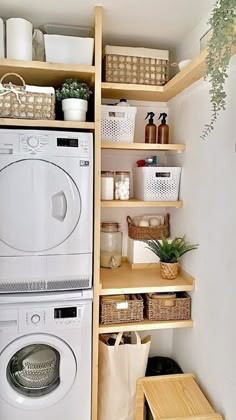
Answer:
[0,73,55,120]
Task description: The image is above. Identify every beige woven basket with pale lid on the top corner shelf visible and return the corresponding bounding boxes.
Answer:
[104,45,169,86]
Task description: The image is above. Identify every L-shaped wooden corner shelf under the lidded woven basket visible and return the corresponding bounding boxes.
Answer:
[102,47,236,102]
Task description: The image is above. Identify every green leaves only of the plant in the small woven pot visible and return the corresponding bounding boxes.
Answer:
[144,237,198,264]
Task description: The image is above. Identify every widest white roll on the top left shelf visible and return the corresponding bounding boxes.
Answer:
[6,18,33,60]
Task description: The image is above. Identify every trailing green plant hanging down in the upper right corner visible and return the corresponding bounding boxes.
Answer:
[201,0,236,140]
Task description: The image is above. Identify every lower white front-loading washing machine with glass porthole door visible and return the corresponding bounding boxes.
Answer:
[0,290,92,420]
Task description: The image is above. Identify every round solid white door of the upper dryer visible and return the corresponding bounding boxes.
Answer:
[0,159,81,252]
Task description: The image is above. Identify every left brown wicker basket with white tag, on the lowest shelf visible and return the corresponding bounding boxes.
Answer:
[100,295,144,324]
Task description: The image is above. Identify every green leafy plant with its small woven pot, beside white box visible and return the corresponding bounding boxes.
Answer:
[144,237,198,280]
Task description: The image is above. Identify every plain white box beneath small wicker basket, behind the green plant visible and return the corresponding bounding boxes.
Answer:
[127,237,159,264]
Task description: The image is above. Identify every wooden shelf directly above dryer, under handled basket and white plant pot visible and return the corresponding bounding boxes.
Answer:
[0,118,95,130]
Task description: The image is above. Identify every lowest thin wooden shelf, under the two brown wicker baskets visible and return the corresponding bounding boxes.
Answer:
[98,319,193,334]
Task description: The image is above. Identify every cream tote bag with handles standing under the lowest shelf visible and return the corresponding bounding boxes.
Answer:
[98,332,151,420]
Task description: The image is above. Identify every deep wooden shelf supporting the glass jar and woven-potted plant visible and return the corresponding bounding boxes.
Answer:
[100,262,195,295]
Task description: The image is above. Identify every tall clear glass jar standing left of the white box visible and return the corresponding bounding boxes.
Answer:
[100,222,123,268]
